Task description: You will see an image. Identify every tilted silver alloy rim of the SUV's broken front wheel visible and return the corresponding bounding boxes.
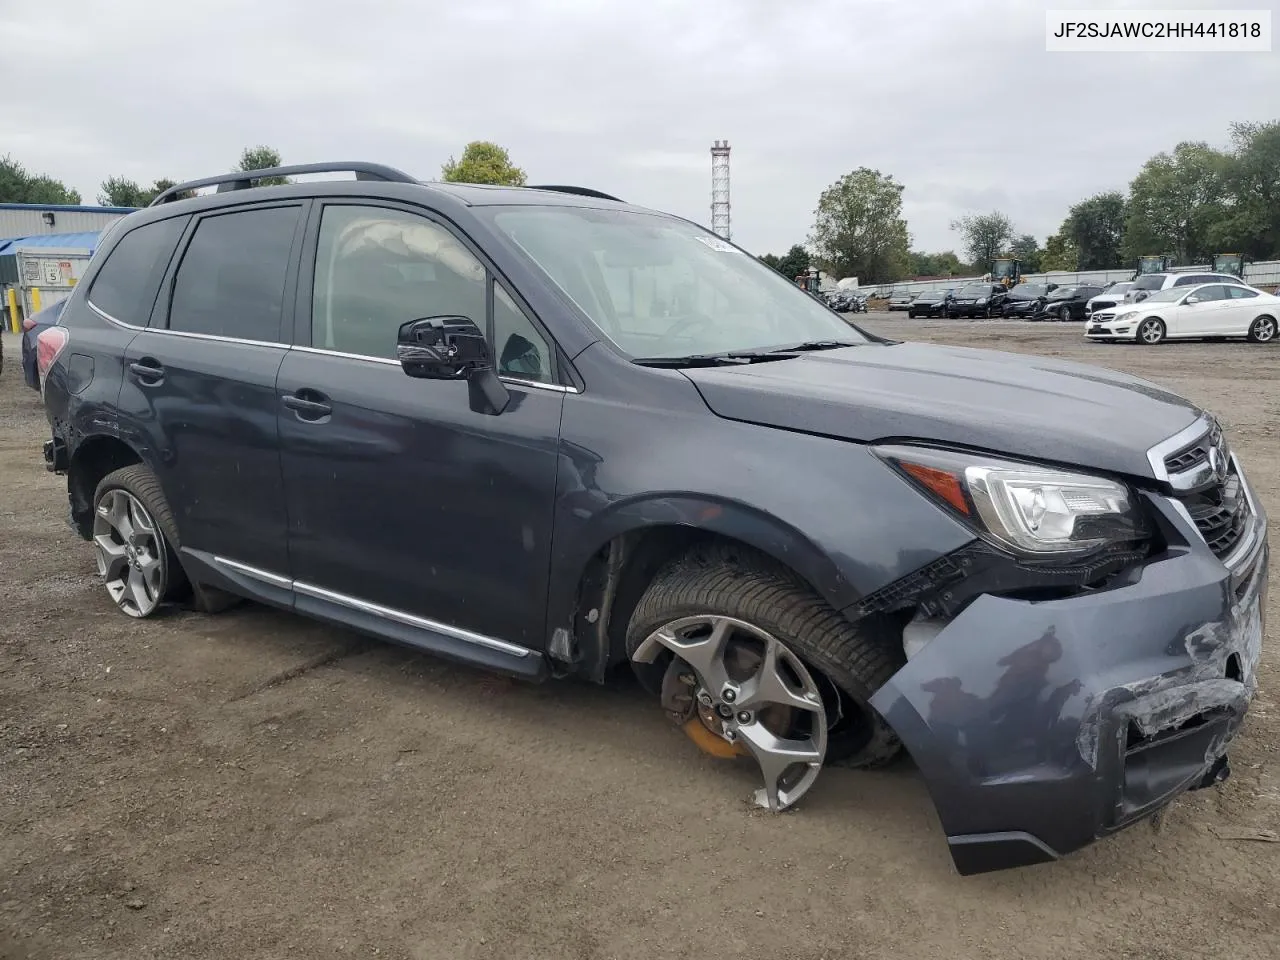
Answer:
[632,614,827,812]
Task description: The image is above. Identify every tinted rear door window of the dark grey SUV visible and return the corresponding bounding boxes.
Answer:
[169,206,302,343]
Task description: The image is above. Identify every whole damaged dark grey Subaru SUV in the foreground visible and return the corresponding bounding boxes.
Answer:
[38,164,1268,873]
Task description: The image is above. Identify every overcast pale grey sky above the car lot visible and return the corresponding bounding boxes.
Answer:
[0,0,1280,253]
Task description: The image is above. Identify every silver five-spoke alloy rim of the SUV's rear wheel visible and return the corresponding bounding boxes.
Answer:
[93,488,168,617]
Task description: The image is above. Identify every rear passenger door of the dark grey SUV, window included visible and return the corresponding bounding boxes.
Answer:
[120,202,306,577]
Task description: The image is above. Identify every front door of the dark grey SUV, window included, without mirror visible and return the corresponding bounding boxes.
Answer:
[278,204,564,649]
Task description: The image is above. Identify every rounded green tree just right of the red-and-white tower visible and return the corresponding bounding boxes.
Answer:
[809,166,910,283]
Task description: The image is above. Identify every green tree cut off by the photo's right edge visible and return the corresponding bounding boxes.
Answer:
[1210,120,1280,260]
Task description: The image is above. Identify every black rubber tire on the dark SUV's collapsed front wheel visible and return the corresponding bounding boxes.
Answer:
[627,547,906,768]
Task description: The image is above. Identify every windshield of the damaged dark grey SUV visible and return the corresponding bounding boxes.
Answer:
[490,206,869,358]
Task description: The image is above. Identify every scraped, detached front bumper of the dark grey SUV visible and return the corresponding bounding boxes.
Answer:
[872,495,1268,874]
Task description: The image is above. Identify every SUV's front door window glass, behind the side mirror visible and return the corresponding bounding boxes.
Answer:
[311,205,486,360]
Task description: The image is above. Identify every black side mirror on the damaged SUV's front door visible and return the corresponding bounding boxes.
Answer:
[396,316,511,416]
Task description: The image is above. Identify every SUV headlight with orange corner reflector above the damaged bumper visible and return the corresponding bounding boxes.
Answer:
[876,445,1147,557]
